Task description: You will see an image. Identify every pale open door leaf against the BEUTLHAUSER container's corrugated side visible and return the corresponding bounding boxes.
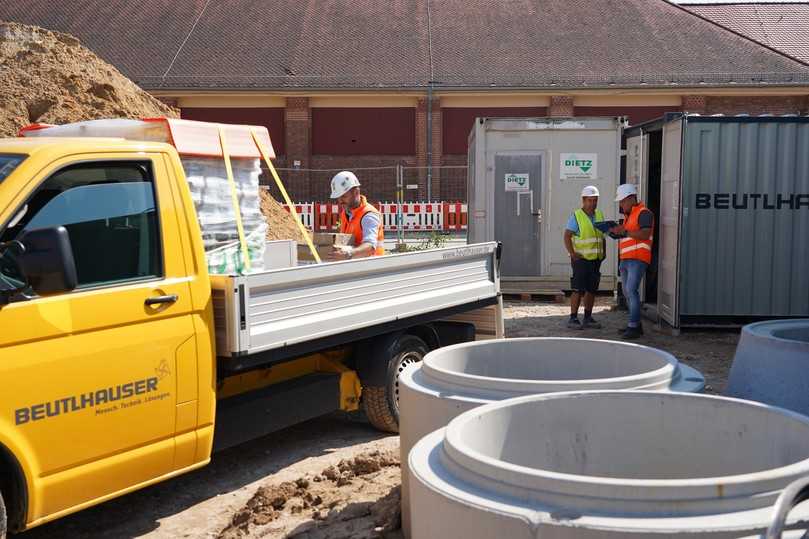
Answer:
[654,120,683,327]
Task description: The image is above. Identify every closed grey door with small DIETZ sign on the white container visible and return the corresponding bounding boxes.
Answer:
[494,153,543,277]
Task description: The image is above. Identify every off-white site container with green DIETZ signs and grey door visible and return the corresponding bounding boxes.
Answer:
[468,118,625,294]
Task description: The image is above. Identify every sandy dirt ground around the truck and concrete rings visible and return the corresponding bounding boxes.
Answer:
[23,300,738,539]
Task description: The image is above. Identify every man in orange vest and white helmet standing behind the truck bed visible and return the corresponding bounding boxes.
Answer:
[329,170,385,260]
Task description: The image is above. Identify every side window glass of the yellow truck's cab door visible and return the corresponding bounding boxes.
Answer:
[2,161,163,288]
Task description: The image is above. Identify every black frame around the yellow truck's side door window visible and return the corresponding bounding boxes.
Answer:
[0,155,166,300]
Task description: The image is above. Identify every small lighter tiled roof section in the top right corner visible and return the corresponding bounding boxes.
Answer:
[685,2,809,63]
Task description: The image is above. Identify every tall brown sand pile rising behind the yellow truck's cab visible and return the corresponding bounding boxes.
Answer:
[0,22,178,137]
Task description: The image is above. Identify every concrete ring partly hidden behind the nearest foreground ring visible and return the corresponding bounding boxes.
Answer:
[399,337,705,536]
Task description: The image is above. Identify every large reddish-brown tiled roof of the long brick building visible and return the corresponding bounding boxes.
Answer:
[0,0,809,90]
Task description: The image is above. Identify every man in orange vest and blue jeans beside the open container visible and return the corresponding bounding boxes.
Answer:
[610,183,654,339]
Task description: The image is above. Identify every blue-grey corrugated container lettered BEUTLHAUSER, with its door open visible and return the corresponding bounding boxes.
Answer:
[625,114,809,327]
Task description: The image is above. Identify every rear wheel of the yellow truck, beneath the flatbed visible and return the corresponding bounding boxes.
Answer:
[362,335,430,432]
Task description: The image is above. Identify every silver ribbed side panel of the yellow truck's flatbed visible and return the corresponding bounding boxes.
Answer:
[211,242,500,370]
